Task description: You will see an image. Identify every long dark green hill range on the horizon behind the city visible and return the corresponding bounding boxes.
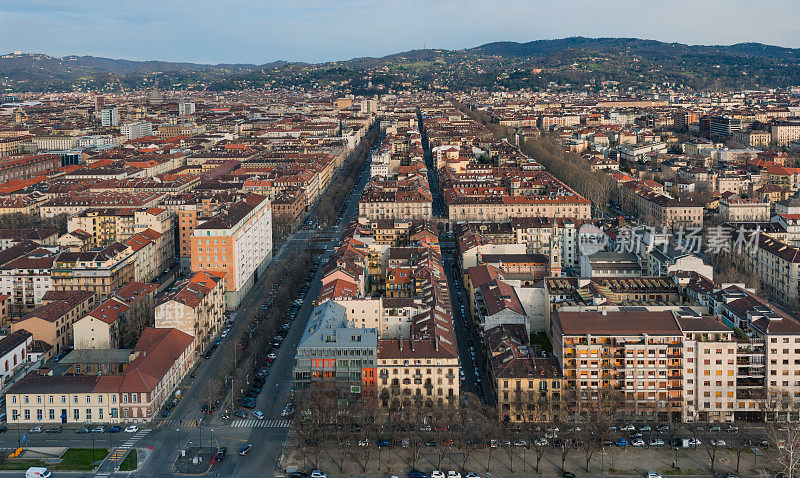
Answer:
[0,37,800,93]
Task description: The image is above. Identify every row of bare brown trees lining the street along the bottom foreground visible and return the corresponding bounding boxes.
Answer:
[293,382,800,478]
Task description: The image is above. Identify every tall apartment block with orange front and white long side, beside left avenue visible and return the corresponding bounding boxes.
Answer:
[191,194,272,310]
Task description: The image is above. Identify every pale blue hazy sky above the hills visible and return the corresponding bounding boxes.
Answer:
[0,0,800,64]
